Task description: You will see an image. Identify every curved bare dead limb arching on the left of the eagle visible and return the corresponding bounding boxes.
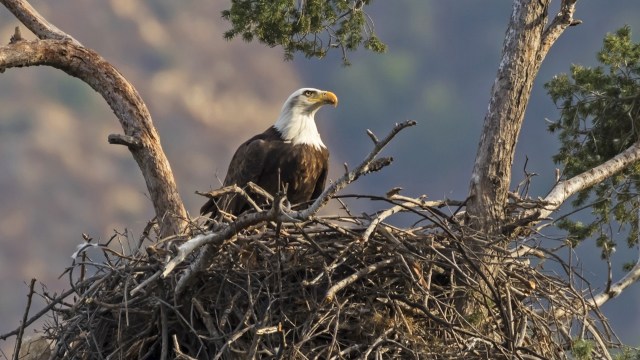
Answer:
[0,0,187,236]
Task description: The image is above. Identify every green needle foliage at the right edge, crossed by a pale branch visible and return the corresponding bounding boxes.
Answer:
[545,26,640,257]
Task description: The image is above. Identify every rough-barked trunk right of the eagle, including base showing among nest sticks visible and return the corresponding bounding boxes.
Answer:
[456,0,576,318]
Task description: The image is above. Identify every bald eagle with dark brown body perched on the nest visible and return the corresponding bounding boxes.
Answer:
[200,88,338,218]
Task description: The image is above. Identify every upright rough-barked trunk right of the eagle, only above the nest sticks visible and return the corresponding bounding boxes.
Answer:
[467,0,575,229]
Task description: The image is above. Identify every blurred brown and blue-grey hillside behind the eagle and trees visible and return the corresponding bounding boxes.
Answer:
[0,0,640,348]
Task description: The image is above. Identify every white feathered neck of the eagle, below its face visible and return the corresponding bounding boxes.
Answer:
[273,106,325,149]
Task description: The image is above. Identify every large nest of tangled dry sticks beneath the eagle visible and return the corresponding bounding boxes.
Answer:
[13,194,609,359]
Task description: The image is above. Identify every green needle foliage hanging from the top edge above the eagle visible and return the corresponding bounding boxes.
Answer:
[222,0,386,64]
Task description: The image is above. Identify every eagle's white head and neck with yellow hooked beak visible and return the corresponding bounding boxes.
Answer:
[273,88,338,148]
